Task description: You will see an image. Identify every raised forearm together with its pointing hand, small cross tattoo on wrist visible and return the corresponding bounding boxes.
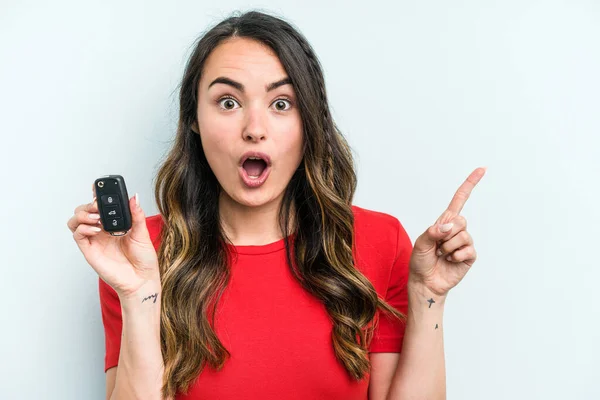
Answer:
[387,168,486,400]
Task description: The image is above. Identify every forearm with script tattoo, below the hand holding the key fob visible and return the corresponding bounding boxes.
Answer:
[110,283,164,400]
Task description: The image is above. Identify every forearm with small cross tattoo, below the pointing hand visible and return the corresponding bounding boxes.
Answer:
[387,279,446,400]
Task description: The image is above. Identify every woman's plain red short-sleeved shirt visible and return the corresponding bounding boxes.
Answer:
[99,206,412,400]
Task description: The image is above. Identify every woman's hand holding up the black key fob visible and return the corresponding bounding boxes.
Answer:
[67,184,160,298]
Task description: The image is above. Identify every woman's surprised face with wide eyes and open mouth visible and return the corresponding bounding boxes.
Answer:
[197,38,303,207]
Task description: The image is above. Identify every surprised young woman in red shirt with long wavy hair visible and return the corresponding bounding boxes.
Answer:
[68,12,485,400]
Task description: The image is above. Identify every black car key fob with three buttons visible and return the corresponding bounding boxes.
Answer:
[94,175,131,236]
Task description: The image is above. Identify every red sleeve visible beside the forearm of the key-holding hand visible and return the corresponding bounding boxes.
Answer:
[98,277,123,372]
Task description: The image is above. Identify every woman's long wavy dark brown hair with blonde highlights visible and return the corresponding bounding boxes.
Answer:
[155,11,405,397]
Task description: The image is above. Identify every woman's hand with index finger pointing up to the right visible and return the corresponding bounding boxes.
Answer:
[410,168,486,296]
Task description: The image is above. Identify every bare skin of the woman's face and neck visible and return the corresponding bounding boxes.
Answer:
[193,38,303,245]
